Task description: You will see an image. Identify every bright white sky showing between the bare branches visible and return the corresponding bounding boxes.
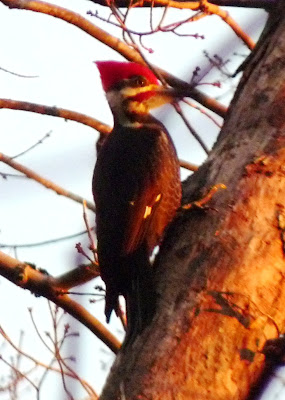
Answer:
[0,0,276,400]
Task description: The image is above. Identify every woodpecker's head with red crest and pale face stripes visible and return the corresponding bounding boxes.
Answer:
[95,61,174,125]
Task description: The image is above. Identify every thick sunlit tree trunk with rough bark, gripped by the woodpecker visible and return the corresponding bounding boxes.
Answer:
[98,2,285,400]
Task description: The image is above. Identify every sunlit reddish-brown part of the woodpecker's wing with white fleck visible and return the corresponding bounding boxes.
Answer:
[123,185,162,255]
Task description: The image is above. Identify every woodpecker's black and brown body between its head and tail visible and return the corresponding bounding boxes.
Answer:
[93,119,181,336]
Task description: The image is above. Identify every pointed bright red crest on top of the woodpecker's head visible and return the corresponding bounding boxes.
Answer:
[95,61,159,92]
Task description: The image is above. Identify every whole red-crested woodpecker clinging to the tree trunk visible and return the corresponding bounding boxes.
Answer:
[93,61,181,337]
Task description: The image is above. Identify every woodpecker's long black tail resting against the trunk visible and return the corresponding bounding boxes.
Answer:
[123,247,156,342]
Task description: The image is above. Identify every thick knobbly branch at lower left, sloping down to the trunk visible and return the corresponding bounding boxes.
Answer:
[0,252,120,353]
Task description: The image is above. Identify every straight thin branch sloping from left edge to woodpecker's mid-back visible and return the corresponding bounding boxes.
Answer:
[0,153,95,211]
